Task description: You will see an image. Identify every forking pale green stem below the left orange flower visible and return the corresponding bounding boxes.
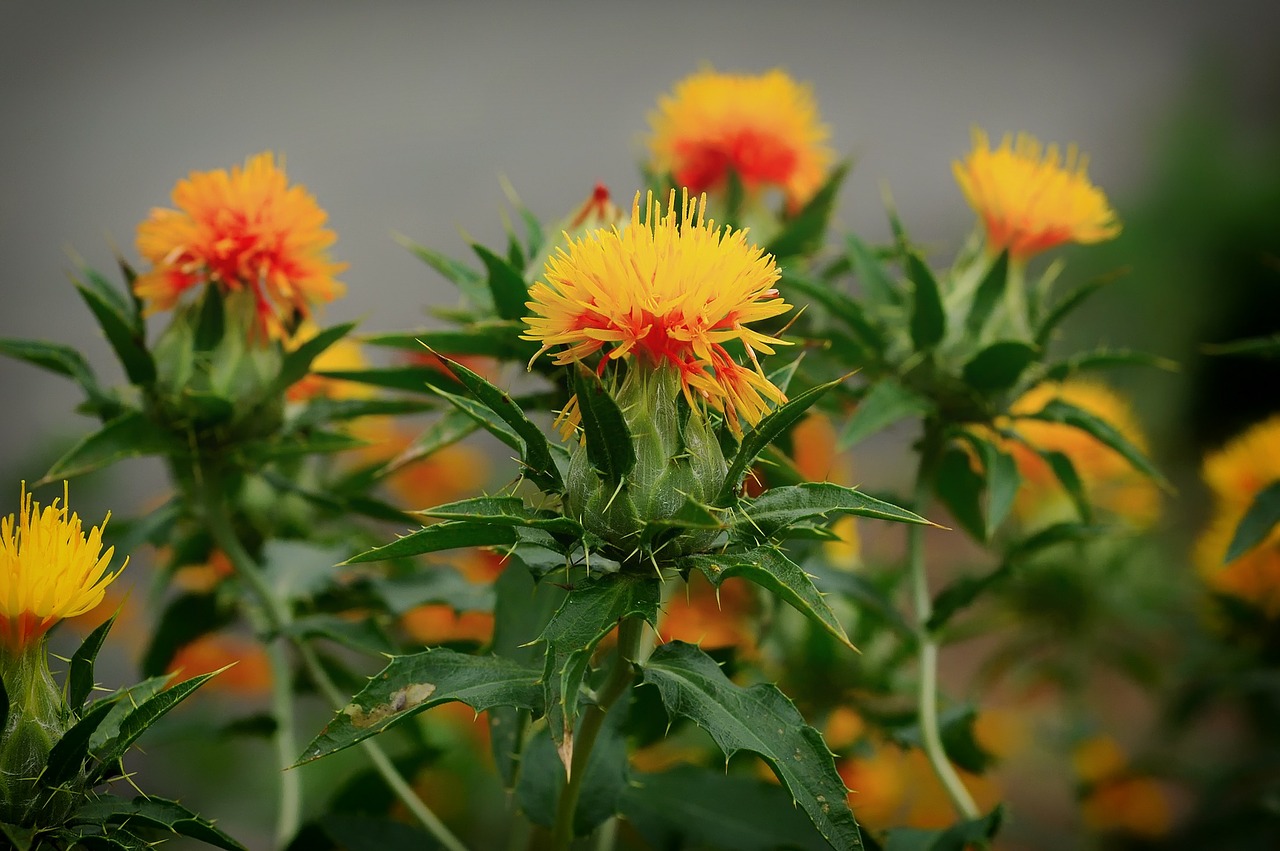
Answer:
[198,472,467,851]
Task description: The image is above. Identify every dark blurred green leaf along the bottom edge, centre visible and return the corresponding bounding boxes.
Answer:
[621,765,831,851]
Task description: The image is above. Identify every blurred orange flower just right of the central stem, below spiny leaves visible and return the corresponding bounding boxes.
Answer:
[658,571,755,654]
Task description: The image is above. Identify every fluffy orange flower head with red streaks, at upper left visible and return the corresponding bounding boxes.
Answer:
[133,154,347,339]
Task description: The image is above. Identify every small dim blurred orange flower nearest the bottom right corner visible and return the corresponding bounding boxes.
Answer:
[1071,736,1172,839]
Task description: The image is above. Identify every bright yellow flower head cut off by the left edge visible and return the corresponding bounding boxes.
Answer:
[0,482,128,648]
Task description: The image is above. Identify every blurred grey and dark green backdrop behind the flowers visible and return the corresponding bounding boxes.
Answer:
[0,0,1280,844]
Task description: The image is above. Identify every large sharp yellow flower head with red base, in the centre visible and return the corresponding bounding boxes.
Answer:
[521,191,791,430]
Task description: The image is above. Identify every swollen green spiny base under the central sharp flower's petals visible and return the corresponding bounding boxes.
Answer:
[567,369,728,562]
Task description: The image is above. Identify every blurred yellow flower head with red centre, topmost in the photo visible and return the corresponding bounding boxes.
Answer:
[649,69,835,210]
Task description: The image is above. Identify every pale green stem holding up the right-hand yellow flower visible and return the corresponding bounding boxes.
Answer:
[906,437,979,820]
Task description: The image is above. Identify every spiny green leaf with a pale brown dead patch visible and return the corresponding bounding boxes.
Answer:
[297,648,543,765]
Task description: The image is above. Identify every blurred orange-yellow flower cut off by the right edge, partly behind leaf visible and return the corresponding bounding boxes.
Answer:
[1196,416,1280,618]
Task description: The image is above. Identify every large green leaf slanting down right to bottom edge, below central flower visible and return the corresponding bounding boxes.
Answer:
[644,641,863,851]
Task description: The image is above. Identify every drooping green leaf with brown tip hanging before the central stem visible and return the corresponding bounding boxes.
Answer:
[538,573,662,769]
